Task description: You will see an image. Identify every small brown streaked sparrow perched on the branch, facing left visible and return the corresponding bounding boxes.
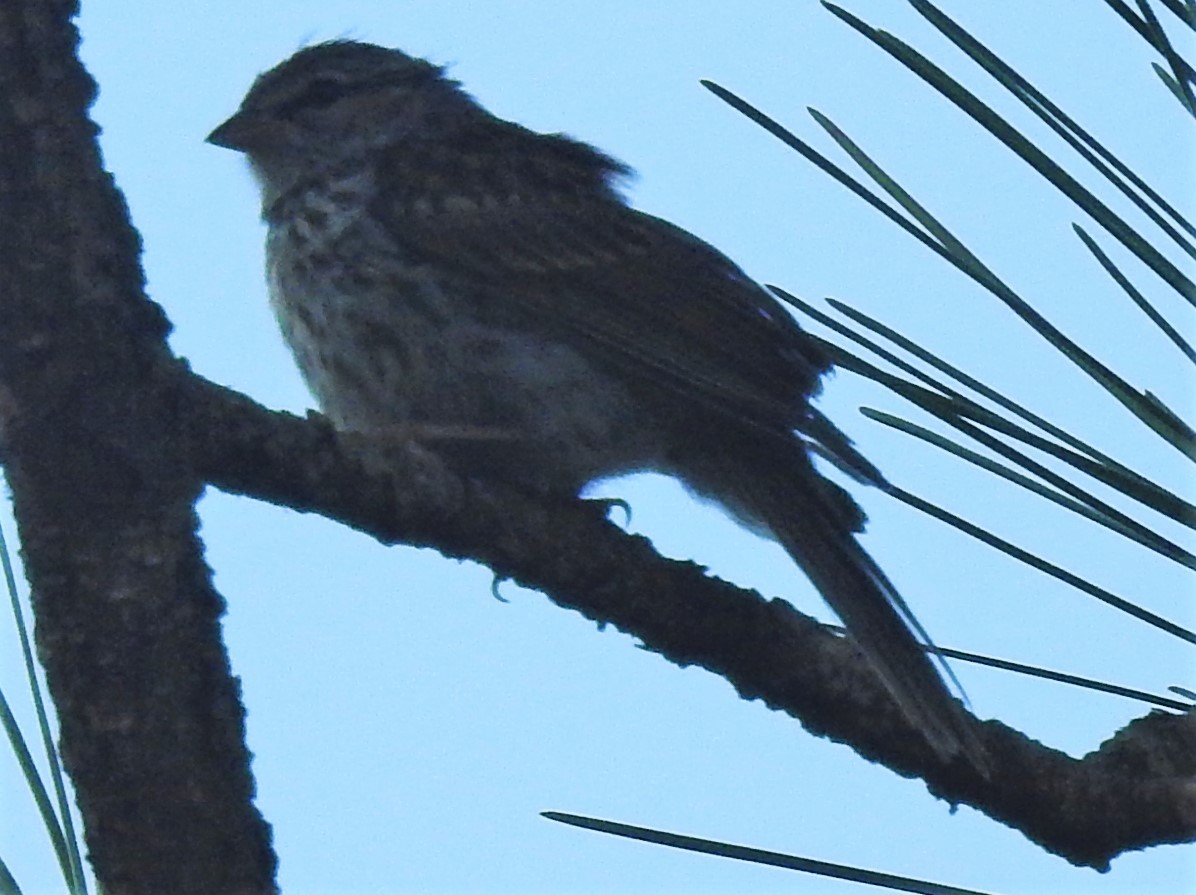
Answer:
[208,41,976,759]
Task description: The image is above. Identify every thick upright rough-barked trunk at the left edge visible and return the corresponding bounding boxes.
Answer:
[0,0,275,895]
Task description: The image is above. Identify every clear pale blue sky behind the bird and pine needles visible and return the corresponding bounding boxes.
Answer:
[0,0,1196,895]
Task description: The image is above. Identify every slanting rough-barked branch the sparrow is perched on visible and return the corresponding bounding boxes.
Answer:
[183,377,1196,869]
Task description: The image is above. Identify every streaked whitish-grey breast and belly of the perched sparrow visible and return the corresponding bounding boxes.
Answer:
[259,177,660,493]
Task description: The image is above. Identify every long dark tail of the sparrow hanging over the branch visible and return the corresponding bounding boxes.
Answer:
[691,437,989,773]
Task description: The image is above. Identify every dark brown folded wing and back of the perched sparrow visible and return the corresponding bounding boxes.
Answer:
[373,123,828,431]
